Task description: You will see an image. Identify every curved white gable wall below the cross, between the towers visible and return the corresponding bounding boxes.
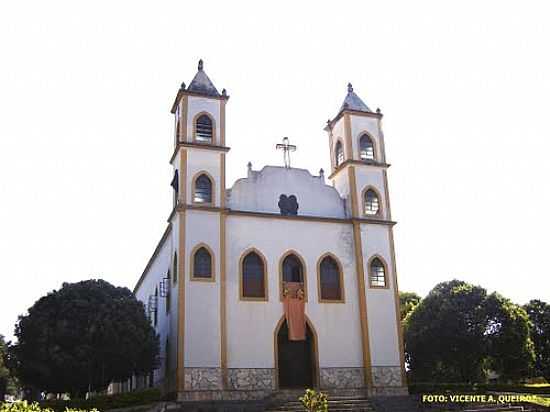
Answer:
[227,166,346,218]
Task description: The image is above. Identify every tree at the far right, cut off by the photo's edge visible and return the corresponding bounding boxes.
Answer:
[524,300,550,382]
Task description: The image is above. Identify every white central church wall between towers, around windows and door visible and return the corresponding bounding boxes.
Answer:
[227,216,362,368]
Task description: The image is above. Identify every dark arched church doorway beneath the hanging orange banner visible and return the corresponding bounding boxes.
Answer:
[275,317,317,389]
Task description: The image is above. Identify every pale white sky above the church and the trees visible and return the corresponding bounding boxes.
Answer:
[0,0,550,337]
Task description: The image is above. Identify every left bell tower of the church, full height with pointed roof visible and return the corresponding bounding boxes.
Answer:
[170,60,229,391]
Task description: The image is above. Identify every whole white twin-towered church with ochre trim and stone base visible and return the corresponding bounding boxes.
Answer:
[134,61,406,401]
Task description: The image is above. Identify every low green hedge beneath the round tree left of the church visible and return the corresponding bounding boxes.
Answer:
[40,389,167,412]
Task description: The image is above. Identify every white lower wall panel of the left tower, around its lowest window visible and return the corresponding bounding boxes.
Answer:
[185,209,220,368]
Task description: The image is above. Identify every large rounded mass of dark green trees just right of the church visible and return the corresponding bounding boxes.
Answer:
[405,280,533,383]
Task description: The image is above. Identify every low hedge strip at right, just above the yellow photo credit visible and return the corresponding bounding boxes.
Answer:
[409,383,550,395]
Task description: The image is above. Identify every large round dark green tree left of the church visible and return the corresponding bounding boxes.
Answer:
[12,280,159,396]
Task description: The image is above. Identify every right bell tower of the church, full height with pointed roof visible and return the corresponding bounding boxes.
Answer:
[325,84,405,393]
